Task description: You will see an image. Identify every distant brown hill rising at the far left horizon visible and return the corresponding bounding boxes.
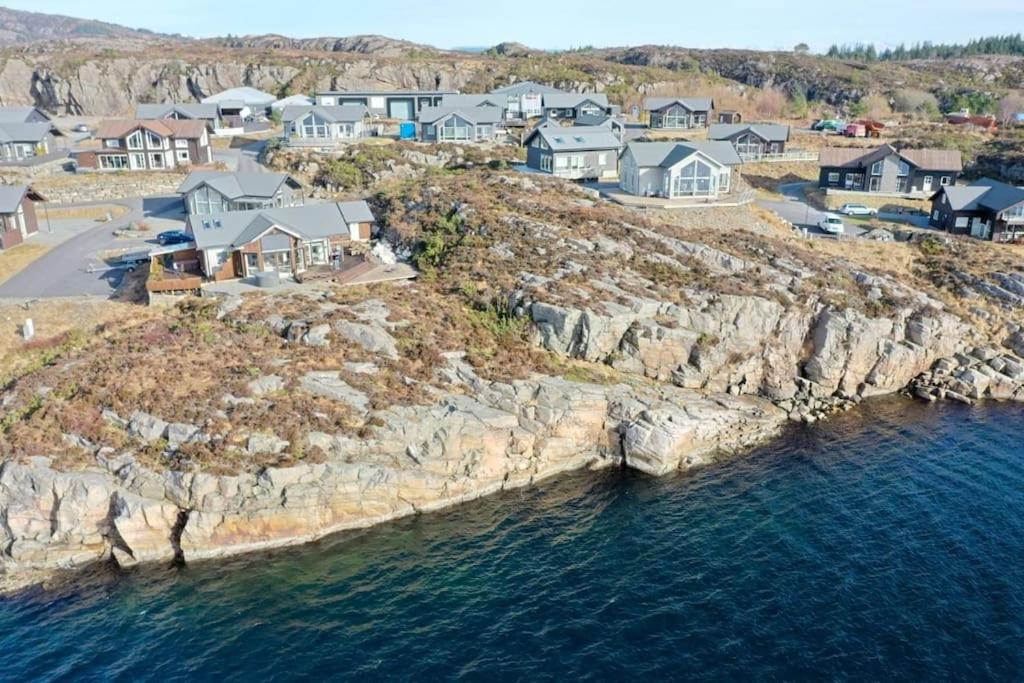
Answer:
[0,7,181,46]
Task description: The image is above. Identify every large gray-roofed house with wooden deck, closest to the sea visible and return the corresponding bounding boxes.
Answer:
[182,201,376,281]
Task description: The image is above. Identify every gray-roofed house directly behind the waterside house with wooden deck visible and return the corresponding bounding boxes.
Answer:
[177,171,304,214]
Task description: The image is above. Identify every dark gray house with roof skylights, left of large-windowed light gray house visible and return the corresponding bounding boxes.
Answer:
[523,124,622,180]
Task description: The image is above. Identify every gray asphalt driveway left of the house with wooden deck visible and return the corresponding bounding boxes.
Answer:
[0,196,184,298]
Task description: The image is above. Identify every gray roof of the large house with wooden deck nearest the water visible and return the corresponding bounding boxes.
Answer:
[188,201,375,249]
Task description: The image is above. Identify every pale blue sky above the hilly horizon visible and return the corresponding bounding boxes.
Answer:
[14,0,1024,51]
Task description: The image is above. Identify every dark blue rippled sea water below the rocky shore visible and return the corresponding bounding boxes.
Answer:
[0,399,1024,681]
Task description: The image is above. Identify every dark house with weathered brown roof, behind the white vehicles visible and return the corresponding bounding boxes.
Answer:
[818,144,964,195]
